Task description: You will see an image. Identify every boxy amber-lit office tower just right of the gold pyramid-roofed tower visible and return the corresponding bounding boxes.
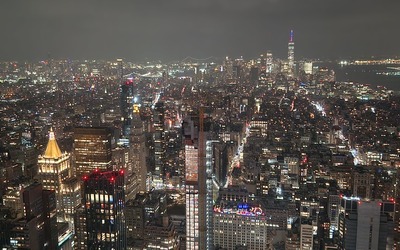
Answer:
[74,127,112,177]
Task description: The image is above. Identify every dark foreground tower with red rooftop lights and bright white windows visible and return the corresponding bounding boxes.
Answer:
[83,170,126,250]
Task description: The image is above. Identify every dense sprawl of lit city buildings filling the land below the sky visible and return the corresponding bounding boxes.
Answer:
[0,31,400,250]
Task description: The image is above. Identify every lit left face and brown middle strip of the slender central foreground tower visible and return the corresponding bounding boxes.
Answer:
[183,114,207,249]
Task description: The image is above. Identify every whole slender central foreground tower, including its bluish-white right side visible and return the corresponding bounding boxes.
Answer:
[183,112,213,249]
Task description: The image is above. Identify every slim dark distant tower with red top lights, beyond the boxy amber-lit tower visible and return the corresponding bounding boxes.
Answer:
[121,80,134,138]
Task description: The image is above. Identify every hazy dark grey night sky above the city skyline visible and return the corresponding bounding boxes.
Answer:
[0,0,400,61]
